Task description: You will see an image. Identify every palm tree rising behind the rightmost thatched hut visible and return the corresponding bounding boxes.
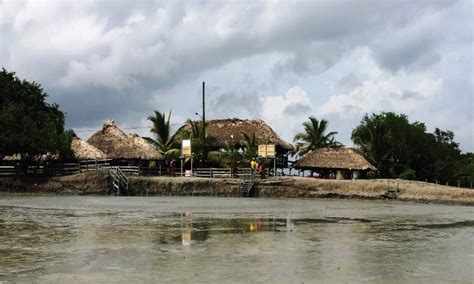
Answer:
[293,116,342,156]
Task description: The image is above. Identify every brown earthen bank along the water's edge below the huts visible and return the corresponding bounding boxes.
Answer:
[0,172,474,205]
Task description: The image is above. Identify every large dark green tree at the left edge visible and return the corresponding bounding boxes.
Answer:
[0,69,72,159]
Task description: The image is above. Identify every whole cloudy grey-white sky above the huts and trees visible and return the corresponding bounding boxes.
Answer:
[0,0,474,151]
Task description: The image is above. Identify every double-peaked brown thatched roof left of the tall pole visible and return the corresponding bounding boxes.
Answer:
[87,121,163,160]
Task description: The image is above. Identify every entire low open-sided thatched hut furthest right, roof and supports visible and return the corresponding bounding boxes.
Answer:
[293,148,377,179]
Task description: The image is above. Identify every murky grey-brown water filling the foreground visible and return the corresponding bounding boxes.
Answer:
[0,196,474,283]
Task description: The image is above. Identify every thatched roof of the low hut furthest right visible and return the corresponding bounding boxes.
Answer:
[293,148,377,171]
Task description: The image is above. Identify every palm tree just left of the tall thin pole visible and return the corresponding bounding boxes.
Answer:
[148,110,179,157]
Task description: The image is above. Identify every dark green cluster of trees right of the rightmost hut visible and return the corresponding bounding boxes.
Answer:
[351,112,474,186]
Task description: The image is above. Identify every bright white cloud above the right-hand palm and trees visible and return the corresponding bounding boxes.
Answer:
[318,50,442,119]
